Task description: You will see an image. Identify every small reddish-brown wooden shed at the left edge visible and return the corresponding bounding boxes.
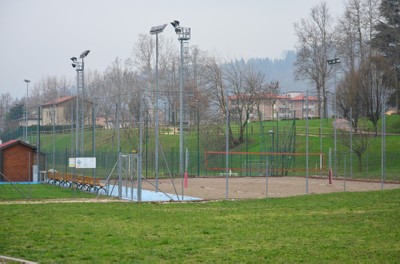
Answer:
[0,140,37,182]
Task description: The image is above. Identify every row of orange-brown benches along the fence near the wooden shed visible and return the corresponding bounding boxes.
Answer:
[47,172,107,193]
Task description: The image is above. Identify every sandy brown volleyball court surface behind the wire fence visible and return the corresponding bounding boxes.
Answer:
[143,177,400,200]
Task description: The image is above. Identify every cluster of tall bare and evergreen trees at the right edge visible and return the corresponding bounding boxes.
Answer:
[294,0,400,134]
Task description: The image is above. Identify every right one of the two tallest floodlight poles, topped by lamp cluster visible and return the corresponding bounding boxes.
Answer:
[171,20,191,199]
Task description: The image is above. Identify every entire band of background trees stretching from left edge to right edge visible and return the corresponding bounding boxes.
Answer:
[0,0,400,153]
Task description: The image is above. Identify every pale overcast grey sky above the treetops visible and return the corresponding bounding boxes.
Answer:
[0,0,344,98]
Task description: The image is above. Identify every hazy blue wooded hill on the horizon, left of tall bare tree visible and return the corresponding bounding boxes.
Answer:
[248,51,313,93]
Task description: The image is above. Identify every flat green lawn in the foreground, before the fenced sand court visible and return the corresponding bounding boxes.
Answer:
[0,185,400,263]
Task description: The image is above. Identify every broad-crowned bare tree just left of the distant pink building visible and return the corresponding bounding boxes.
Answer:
[204,57,265,146]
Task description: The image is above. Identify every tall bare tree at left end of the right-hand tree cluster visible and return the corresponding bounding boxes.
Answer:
[294,2,334,117]
